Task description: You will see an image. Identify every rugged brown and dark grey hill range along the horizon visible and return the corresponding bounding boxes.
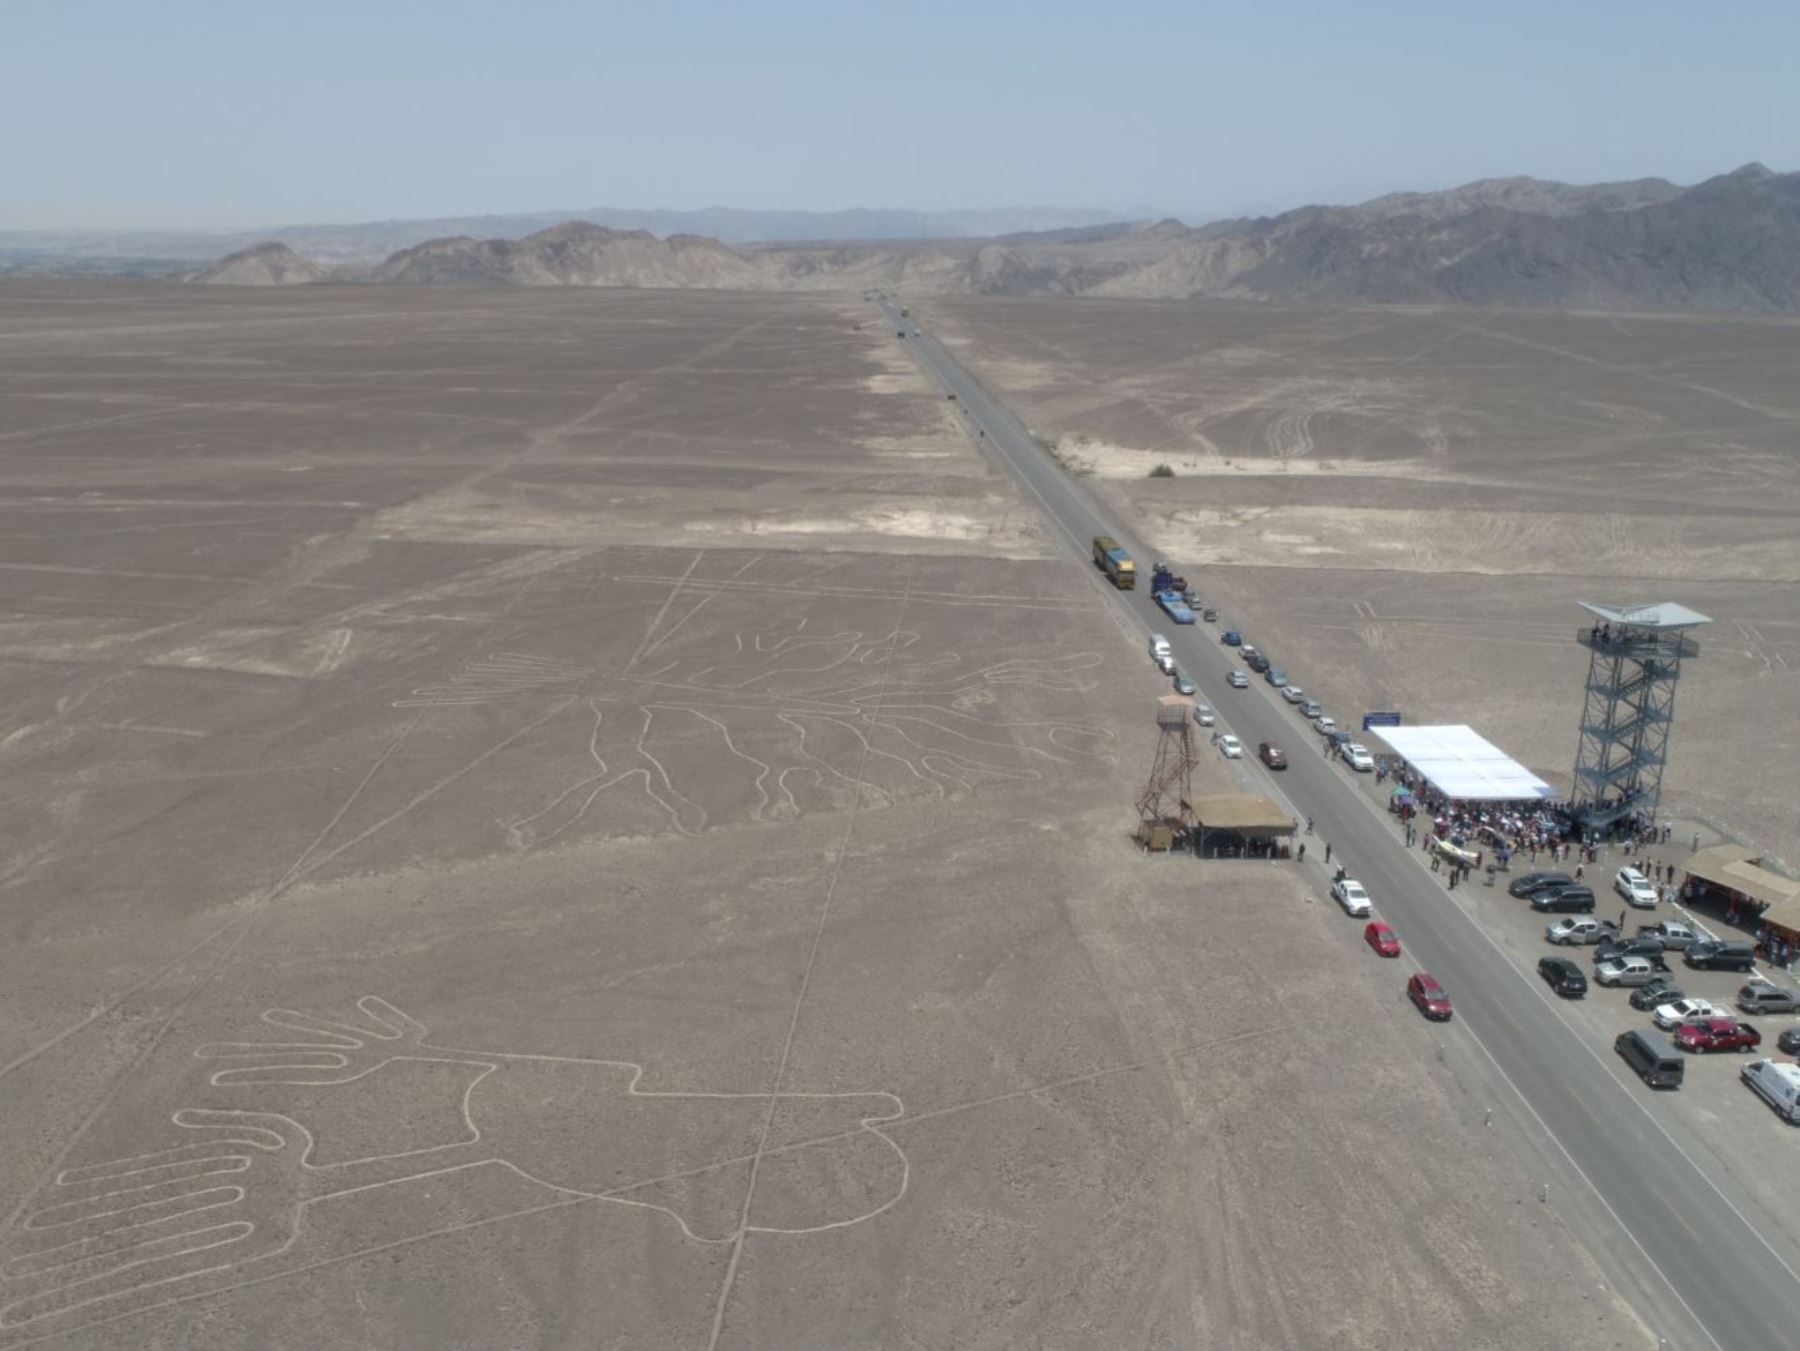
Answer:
[182,164,1800,313]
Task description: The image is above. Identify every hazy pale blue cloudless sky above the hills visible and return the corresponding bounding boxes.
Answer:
[0,0,1800,227]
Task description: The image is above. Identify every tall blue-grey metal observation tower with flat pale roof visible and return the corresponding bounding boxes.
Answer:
[1570,601,1710,829]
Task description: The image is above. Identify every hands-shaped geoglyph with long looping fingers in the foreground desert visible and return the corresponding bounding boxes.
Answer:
[0,997,907,1346]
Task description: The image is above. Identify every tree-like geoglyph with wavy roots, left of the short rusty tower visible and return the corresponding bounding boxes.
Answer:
[486,617,1112,849]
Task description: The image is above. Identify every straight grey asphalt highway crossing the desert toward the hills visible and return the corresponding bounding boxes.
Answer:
[877,300,1800,1351]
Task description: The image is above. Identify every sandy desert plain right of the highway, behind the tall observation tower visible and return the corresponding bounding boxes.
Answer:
[923,299,1800,863]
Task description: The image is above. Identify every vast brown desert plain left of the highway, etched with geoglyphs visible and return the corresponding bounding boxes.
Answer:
[0,284,1645,1347]
